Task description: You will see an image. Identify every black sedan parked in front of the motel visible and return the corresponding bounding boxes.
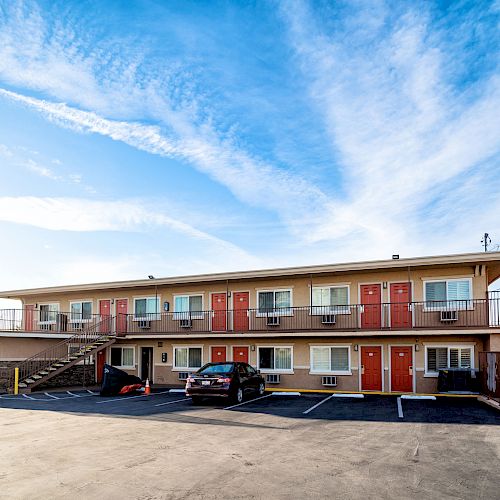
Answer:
[186,361,266,403]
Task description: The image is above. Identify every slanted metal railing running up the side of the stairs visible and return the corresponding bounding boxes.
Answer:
[0,318,113,390]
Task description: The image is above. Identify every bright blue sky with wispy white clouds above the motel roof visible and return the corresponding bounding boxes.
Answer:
[0,0,500,289]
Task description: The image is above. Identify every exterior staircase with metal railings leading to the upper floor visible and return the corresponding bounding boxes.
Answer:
[7,319,116,394]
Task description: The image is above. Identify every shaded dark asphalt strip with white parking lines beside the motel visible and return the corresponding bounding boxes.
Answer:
[0,389,500,425]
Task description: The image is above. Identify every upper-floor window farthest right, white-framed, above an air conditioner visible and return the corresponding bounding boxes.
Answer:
[424,278,472,311]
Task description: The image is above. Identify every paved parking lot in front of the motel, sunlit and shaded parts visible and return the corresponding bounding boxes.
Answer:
[0,390,500,499]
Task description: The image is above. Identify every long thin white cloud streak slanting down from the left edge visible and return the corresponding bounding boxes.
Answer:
[0,89,328,238]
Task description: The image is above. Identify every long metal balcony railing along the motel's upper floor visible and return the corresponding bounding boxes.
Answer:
[0,294,500,335]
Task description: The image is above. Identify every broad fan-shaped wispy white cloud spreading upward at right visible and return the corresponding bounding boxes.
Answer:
[282,2,500,258]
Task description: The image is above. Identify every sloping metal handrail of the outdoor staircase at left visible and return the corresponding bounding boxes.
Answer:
[7,317,115,390]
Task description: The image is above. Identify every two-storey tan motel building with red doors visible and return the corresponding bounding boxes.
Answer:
[0,252,500,393]
